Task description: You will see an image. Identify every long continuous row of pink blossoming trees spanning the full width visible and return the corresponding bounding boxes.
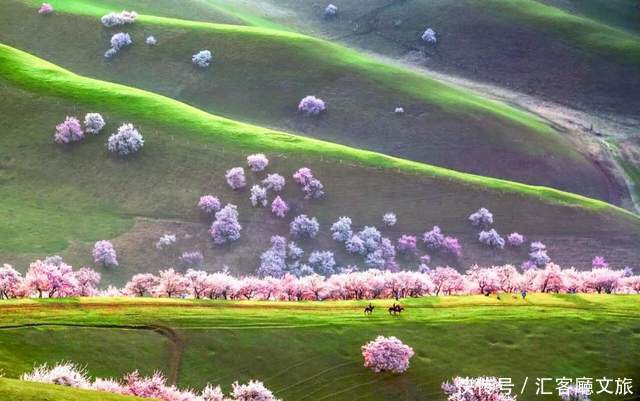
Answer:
[0,257,640,301]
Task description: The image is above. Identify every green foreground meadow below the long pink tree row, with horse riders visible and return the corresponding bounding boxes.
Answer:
[0,295,640,401]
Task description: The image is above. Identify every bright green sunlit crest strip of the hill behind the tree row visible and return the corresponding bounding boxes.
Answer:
[0,43,640,223]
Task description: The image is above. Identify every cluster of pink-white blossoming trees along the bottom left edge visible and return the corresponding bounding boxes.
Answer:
[20,362,279,401]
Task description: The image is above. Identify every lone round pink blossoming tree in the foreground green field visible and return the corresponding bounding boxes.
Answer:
[362,336,414,373]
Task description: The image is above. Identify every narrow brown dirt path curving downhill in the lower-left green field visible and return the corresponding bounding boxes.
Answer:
[0,323,184,384]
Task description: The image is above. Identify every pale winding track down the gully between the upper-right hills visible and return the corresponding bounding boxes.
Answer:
[288,0,640,213]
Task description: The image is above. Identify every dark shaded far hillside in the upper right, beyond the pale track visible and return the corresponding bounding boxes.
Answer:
[209,0,640,116]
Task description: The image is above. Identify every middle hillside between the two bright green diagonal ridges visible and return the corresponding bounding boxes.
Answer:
[0,0,620,200]
